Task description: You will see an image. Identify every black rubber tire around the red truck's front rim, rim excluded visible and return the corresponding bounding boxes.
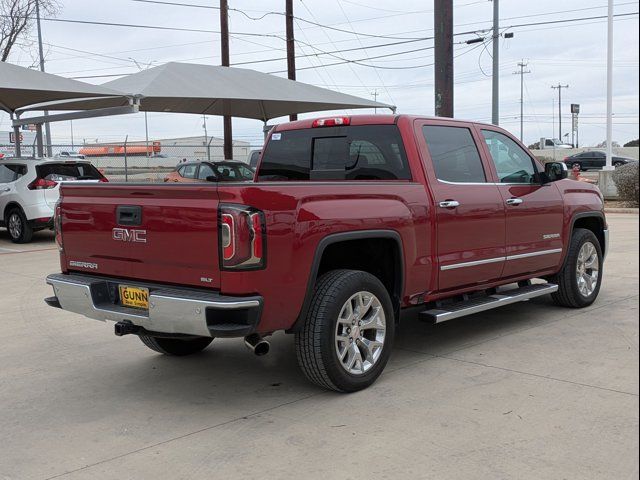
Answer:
[551,228,602,308]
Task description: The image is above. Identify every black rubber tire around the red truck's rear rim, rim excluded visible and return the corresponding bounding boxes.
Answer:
[295,270,395,392]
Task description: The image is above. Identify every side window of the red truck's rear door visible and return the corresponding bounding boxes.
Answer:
[422,125,487,183]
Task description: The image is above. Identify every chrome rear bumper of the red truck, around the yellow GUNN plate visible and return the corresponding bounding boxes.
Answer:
[46,274,262,337]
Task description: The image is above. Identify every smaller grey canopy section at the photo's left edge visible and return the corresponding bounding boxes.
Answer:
[0,62,126,113]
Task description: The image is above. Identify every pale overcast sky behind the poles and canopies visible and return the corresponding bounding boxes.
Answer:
[0,0,639,146]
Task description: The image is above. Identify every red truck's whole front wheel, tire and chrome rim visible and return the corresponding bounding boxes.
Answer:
[552,228,602,308]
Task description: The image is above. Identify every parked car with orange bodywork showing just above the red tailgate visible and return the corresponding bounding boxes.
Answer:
[164,160,254,183]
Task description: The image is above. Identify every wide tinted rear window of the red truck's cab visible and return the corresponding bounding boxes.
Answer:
[258,125,411,181]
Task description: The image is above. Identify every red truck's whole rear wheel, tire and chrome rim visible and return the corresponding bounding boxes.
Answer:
[295,270,395,392]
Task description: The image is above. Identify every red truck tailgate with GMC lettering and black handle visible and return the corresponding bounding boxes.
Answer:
[61,183,220,288]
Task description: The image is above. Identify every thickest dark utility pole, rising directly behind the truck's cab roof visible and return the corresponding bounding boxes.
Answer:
[433,0,456,117]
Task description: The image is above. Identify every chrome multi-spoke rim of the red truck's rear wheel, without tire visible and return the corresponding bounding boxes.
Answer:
[335,291,386,375]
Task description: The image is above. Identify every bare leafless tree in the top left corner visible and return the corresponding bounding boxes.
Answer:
[0,0,60,62]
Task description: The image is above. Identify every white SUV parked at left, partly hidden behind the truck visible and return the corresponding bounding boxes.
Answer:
[0,158,108,243]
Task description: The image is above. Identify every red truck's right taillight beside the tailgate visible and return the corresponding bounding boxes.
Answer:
[219,205,266,270]
